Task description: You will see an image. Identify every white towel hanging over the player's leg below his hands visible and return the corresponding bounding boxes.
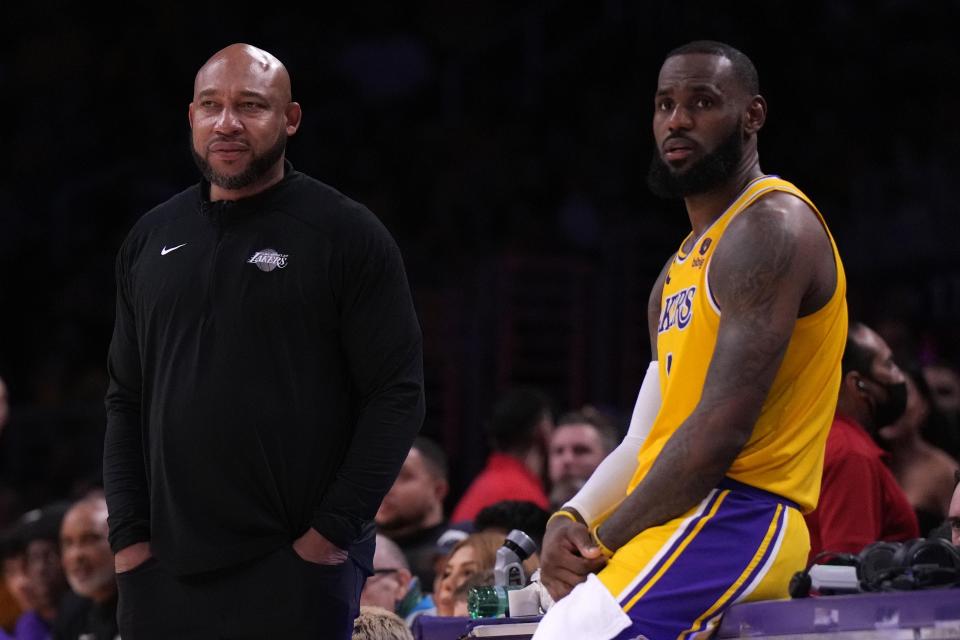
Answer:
[532,573,632,640]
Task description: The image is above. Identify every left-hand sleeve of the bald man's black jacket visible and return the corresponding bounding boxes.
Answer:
[103,244,150,553]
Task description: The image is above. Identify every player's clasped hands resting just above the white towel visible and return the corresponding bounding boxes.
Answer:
[540,518,607,601]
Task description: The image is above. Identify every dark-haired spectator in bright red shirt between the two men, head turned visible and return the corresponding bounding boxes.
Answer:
[450,389,553,522]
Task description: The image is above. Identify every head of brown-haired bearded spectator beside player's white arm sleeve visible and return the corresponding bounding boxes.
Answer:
[547,405,620,510]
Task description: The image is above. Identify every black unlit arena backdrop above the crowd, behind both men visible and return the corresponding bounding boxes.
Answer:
[0,0,960,523]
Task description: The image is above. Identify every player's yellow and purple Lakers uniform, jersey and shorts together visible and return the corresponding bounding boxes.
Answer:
[598,176,847,640]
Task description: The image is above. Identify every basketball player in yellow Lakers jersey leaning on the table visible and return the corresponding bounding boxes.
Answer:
[534,41,847,640]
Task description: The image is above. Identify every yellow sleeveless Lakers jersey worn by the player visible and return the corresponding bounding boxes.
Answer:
[628,176,847,512]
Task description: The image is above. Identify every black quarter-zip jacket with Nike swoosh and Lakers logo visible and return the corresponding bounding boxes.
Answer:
[103,162,424,575]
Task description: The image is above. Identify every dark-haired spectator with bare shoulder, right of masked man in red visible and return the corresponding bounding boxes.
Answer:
[878,375,957,537]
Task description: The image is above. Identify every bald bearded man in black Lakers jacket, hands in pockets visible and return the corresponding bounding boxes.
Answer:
[104,44,424,638]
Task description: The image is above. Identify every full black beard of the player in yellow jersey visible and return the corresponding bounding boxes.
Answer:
[647,120,743,200]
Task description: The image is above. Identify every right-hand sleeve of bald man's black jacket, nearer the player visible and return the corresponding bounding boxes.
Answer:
[312,210,424,549]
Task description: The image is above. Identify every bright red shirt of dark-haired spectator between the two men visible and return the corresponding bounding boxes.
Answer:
[450,453,550,522]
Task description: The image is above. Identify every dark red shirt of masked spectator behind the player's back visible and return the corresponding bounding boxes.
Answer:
[805,414,920,560]
